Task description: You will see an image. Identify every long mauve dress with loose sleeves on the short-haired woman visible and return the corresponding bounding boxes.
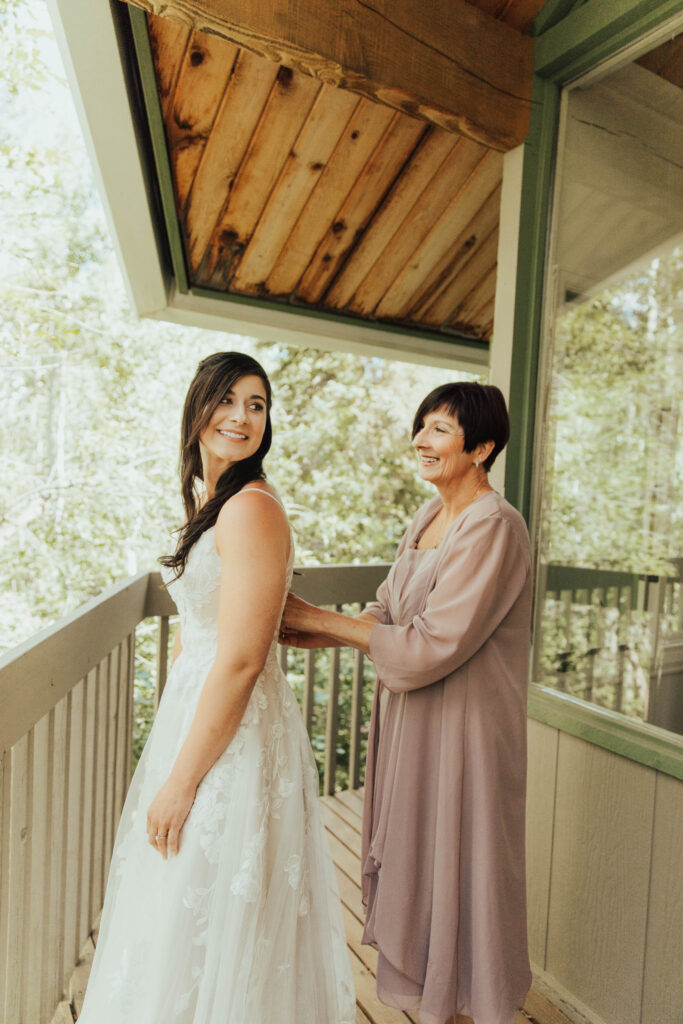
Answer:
[362,492,531,1024]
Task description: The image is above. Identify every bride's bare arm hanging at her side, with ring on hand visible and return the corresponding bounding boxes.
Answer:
[147,492,290,856]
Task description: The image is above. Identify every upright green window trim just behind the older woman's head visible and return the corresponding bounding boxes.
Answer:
[505,75,559,523]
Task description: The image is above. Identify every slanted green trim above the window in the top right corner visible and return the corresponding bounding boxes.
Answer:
[533,0,683,85]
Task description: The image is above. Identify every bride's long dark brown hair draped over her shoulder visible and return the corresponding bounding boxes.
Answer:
[159,352,272,580]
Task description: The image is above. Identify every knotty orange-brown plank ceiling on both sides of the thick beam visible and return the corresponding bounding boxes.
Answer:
[141,0,543,341]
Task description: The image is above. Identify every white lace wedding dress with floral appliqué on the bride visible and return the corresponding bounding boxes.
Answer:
[79,496,355,1024]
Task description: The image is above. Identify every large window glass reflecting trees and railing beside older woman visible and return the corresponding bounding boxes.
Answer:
[533,37,683,733]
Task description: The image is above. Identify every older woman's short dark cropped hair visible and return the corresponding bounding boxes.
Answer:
[413,381,510,472]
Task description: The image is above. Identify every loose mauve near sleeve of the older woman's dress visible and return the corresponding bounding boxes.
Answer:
[370,516,529,692]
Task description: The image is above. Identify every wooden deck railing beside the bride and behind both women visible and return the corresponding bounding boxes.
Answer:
[0,565,387,1024]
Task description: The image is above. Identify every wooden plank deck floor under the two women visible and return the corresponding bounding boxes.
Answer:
[52,791,570,1024]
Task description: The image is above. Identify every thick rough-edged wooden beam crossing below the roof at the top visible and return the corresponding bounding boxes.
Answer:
[121,0,533,152]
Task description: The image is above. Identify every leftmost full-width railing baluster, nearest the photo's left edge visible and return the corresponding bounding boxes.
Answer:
[5,730,33,1021]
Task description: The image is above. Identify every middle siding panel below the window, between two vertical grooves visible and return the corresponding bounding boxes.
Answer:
[546,733,655,1024]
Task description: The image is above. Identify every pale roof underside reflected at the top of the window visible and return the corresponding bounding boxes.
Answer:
[559,59,683,299]
